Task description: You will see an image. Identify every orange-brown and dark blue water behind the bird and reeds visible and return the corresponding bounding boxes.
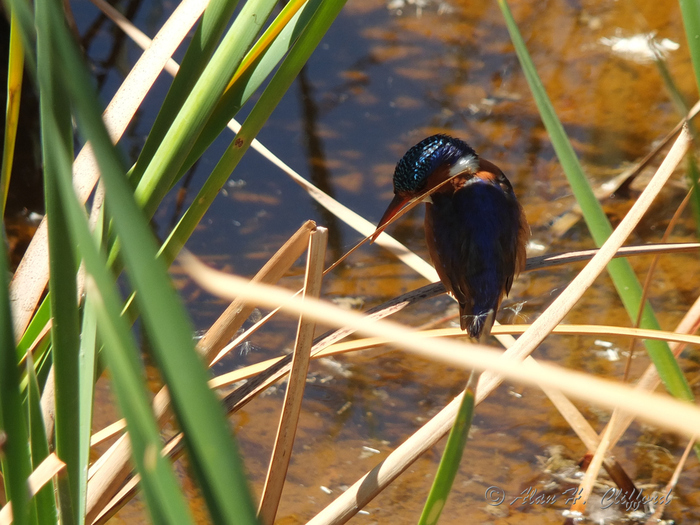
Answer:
[5,0,700,524]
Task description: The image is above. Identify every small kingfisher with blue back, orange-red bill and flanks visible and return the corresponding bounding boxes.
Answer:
[372,134,530,341]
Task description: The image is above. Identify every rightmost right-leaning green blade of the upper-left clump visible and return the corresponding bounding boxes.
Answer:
[161,0,345,261]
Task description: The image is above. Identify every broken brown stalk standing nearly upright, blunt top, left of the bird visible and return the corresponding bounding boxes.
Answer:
[258,227,328,525]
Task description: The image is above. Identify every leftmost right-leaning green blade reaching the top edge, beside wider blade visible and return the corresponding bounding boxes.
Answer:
[131,0,238,184]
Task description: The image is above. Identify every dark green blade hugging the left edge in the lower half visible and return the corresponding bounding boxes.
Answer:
[0,195,32,525]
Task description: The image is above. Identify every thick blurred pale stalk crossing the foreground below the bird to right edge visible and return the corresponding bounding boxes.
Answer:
[180,253,700,436]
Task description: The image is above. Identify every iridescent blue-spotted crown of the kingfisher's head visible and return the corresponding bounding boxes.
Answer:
[394,134,478,194]
